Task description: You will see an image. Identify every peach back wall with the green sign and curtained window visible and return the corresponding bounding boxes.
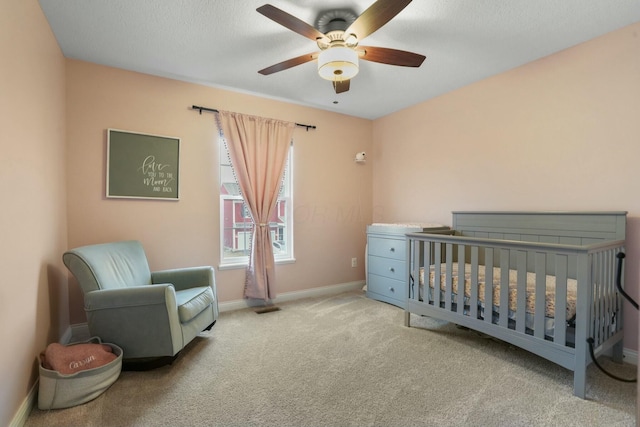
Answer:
[67,60,372,323]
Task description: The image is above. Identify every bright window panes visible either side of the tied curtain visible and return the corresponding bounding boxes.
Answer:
[219,138,293,266]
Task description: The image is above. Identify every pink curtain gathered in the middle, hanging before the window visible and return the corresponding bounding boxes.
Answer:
[218,111,295,301]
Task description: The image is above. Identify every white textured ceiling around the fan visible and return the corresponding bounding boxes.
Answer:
[40,0,640,119]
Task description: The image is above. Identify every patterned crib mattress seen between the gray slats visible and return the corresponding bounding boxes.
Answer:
[420,263,578,319]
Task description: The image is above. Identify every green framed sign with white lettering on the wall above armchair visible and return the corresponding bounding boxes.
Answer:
[106,129,180,200]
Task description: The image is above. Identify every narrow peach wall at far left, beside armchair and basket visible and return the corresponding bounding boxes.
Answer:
[0,0,69,426]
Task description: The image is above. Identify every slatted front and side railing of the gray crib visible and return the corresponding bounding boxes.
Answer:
[405,233,624,397]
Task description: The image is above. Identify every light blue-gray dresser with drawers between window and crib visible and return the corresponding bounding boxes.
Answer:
[366,224,449,308]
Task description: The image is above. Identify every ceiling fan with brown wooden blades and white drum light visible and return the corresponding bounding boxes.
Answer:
[256,0,425,93]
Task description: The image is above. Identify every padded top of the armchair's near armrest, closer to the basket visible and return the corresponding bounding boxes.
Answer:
[84,283,177,310]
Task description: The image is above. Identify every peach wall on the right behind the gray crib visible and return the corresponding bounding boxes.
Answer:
[372,24,640,350]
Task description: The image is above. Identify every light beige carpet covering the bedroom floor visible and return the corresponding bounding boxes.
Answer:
[26,292,636,427]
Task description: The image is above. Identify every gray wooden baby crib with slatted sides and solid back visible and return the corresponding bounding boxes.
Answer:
[405,212,626,399]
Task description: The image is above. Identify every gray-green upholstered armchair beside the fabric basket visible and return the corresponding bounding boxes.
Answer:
[62,240,218,360]
